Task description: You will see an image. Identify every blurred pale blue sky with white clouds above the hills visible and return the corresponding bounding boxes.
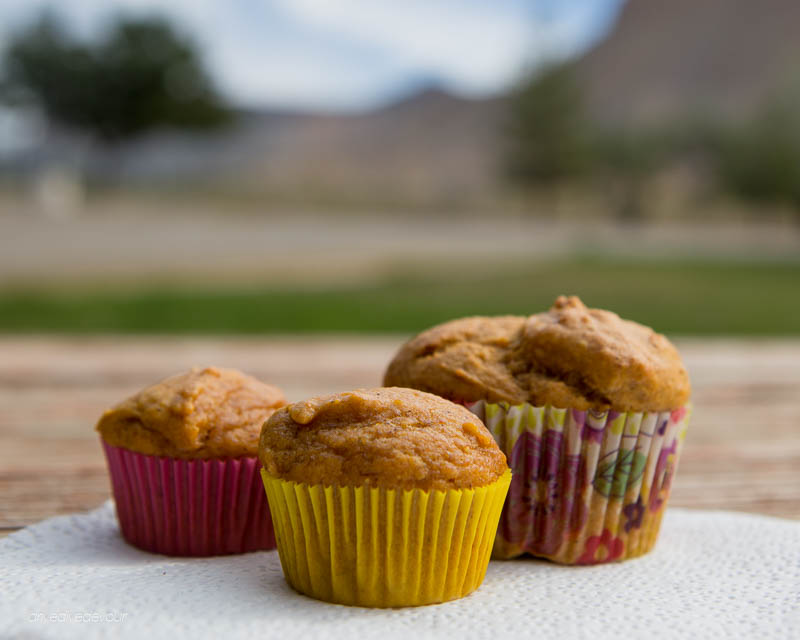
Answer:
[0,0,622,110]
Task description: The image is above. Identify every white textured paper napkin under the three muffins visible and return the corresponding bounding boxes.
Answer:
[0,502,800,640]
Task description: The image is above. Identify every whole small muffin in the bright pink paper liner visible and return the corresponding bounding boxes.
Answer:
[97,367,286,556]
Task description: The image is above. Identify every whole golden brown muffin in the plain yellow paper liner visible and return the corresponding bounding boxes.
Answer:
[259,389,511,607]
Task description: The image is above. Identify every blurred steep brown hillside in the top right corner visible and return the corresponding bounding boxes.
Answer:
[577,0,800,123]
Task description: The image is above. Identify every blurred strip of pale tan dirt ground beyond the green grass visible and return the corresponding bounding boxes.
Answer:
[0,192,800,286]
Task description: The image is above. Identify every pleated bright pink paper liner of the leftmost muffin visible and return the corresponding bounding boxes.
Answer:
[103,441,275,556]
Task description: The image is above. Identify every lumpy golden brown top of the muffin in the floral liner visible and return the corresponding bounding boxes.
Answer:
[384,296,690,411]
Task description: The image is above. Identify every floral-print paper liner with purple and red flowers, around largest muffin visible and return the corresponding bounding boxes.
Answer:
[467,401,689,564]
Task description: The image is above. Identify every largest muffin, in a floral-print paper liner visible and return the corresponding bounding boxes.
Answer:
[384,296,690,564]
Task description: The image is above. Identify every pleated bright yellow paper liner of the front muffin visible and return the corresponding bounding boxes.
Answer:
[261,469,511,607]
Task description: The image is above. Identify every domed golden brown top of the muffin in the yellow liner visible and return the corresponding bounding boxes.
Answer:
[258,388,508,491]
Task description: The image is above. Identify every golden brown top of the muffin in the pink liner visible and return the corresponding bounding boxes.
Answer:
[97,367,286,458]
